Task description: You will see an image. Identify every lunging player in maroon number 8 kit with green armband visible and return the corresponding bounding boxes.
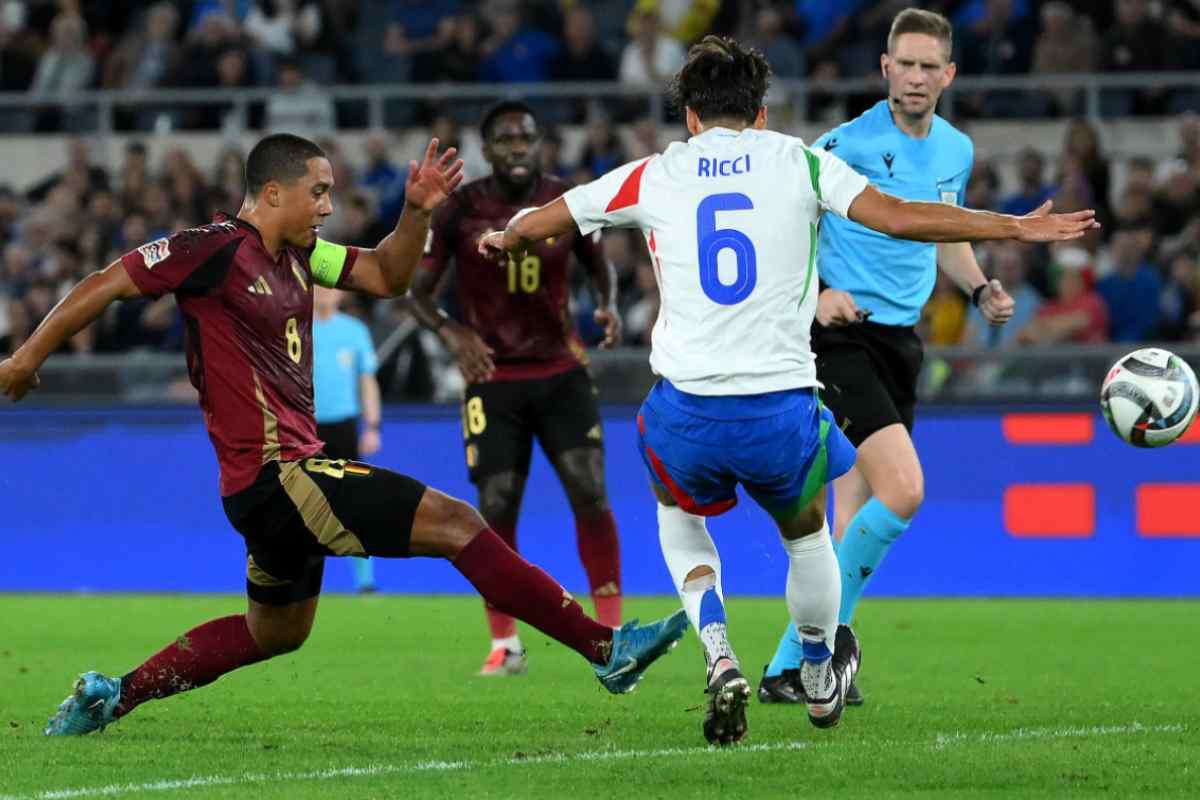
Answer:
[0,134,688,735]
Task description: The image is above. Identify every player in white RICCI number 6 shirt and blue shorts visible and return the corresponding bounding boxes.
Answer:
[479,36,1094,745]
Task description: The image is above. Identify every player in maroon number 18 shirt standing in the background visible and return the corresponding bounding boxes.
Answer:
[409,101,620,675]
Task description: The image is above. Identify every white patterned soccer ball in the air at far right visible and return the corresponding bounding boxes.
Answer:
[1100,348,1200,447]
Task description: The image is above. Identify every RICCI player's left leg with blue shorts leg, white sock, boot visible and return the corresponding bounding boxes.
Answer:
[637,385,750,745]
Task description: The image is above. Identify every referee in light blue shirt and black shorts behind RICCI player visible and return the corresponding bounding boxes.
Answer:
[758,8,1013,705]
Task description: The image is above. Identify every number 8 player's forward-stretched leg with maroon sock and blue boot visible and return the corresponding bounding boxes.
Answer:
[309,459,688,693]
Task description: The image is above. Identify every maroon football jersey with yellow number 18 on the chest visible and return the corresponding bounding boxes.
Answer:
[421,176,604,380]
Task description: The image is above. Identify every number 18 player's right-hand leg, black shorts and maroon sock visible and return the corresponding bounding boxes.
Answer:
[536,368,620,626]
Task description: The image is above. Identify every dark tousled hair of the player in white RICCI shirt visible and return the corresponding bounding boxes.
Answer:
[670,35,770,124]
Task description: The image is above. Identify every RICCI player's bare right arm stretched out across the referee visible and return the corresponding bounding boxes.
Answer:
[847,186,1100,242]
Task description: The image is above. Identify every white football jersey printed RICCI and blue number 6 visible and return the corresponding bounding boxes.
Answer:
[564,127,868,395]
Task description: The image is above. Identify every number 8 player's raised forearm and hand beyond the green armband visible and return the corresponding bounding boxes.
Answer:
[346,139,462,297]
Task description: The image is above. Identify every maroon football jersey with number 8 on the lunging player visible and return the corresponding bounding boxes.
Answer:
[121,215,358,495]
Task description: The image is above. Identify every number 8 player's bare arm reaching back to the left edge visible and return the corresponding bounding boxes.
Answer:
[0,261,142,402]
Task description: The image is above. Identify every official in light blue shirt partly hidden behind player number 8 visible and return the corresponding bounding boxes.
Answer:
[312,287,380,591]
